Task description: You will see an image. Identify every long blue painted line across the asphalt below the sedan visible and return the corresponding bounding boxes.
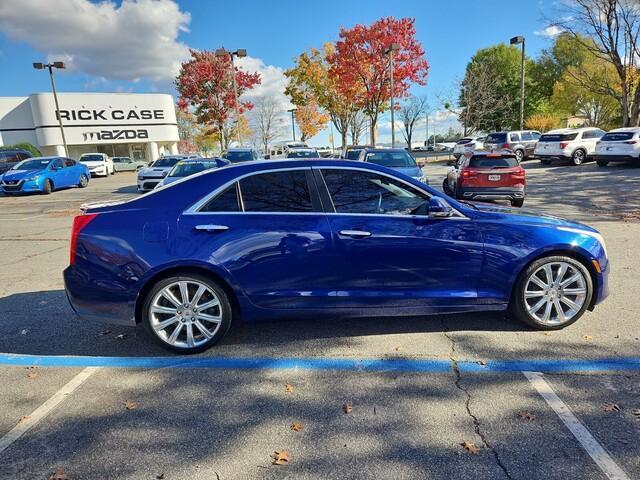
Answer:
[0,354,640,373]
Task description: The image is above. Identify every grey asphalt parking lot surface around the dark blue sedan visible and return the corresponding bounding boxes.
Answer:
[0,161,640,480]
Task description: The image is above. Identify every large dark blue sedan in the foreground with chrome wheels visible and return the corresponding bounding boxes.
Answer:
[64,160,610,353]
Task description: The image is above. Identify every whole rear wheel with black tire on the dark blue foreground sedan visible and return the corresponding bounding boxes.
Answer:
[142,274,233,354]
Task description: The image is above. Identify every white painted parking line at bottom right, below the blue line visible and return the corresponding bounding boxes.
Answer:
[522,372,629,480]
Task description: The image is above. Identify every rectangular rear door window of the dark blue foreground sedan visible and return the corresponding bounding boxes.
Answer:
[240,170,313,212]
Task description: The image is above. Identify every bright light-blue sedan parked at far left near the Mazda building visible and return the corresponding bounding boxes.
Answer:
[0,157,91,194]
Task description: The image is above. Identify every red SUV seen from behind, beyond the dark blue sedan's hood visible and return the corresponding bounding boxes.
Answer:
[442,150,526,207]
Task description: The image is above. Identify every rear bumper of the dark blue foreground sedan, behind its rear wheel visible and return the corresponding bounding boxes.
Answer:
[63,266,136,327]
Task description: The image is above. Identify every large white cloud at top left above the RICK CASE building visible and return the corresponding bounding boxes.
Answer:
[0,0,191,82]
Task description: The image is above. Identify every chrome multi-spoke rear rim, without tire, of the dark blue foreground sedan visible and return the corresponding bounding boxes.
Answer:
[149,280,222,349]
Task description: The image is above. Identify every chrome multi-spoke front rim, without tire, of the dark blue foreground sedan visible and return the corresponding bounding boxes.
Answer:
[524,262,587,325]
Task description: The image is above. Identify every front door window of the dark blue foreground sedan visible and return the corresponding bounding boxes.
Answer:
[322,170,429,215]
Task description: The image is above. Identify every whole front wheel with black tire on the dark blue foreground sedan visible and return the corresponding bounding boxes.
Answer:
[509,256,593,330]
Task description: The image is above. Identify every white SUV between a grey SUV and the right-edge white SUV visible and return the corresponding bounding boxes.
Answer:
[534,127,605,166]
